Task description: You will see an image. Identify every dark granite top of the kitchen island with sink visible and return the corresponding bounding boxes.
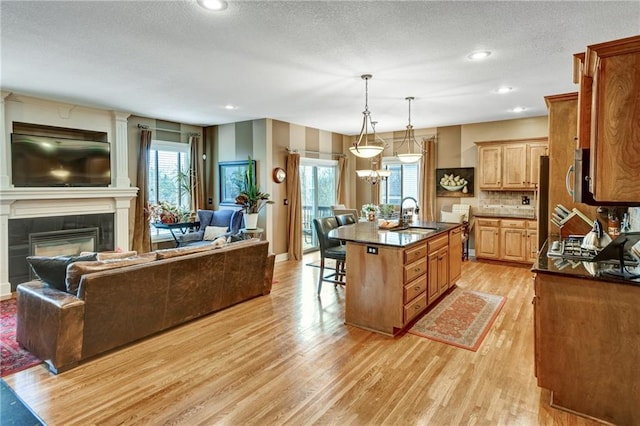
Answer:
[329,221,460,247]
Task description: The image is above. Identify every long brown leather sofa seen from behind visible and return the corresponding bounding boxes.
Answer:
[16,240,275,374]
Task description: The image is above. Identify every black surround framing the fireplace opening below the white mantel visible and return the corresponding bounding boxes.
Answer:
[9,213,115,292]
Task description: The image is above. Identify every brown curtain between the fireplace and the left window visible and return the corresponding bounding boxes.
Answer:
[131,130,151,253]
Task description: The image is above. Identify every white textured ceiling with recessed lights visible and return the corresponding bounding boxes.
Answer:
[0,0,640,134]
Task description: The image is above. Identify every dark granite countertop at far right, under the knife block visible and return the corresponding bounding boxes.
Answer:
[531,237,640,286]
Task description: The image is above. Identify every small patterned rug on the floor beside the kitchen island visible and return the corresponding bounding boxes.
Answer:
[409,288,506,351]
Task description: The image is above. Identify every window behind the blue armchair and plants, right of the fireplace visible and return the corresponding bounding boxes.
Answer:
[147,140,191,240]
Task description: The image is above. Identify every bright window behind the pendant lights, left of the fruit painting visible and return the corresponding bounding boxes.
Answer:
[380,158,420,205]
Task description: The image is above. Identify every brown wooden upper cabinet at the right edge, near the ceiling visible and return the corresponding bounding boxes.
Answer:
[574,36,640,205]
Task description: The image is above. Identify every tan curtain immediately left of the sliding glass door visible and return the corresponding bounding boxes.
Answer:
[287,153,302,260]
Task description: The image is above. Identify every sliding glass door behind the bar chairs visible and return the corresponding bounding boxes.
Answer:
[300,158,338,253]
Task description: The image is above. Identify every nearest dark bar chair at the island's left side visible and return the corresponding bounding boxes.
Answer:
[313,216,347,296]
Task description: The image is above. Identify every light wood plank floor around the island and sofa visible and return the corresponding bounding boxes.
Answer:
[5,257,594,425]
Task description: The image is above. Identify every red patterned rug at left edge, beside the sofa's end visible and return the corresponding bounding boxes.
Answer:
[0,299,42,377]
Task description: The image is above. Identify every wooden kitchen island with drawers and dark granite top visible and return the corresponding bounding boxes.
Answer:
[329,222,462,336]
